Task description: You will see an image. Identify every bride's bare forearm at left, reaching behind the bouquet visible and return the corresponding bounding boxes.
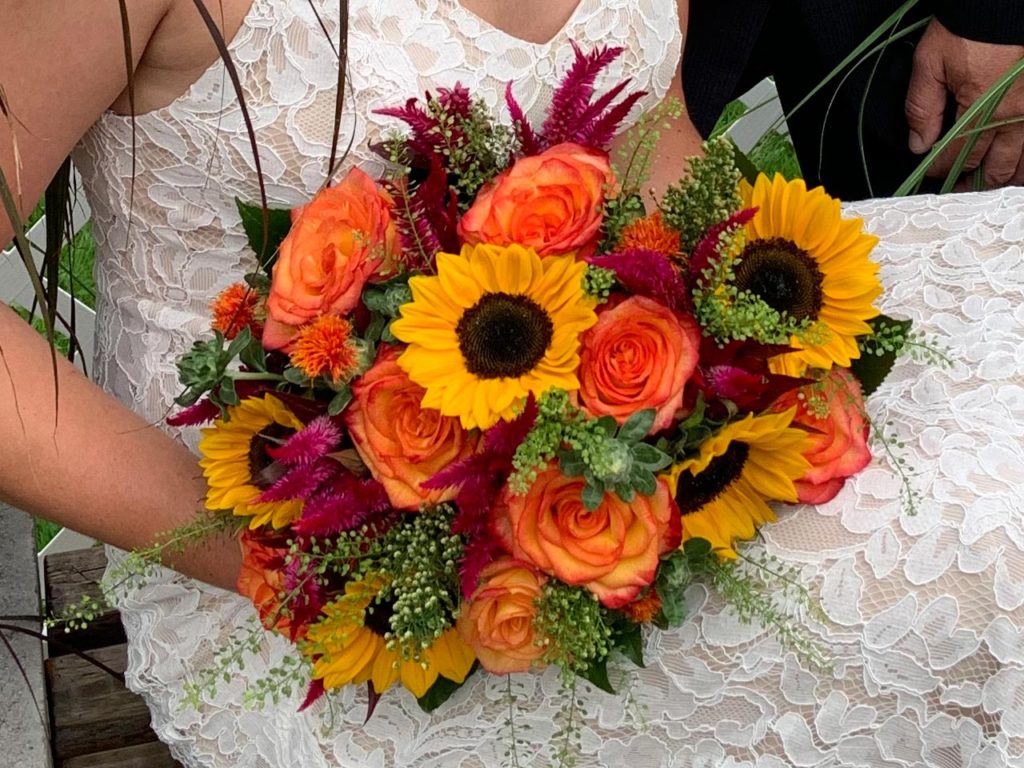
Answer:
[0,305,240,588]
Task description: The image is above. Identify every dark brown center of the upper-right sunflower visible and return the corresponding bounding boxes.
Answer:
[736,238,824,321]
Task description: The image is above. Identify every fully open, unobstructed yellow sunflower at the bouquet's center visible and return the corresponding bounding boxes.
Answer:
[391,245,597,429]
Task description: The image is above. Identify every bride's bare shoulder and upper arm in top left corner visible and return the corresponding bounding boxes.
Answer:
[0,0,253,237]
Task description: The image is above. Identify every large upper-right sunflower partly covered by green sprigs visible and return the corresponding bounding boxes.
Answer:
[735,174,882,376]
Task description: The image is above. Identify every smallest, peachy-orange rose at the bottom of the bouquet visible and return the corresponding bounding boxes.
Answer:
[456,557,547,675]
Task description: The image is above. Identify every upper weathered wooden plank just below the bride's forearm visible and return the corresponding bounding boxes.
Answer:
[44,547,125,656]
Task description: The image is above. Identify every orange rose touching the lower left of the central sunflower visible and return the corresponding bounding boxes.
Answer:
[345,347,480,510]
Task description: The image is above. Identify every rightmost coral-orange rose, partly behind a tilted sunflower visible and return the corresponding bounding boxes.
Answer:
[772,368,871,504]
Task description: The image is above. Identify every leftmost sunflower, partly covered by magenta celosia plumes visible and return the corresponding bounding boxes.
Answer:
[199,395,303,528]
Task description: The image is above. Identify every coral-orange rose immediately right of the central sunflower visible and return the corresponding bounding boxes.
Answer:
[580,296,700,432]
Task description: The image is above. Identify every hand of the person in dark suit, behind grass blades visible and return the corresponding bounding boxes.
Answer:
[906,20,1024,188]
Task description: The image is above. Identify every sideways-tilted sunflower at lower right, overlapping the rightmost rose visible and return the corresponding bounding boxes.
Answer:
[669,409,810,557]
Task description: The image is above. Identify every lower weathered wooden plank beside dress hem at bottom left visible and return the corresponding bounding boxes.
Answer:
[46,645,157,763]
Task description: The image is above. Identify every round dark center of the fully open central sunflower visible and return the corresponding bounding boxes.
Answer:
[455,293,555,379]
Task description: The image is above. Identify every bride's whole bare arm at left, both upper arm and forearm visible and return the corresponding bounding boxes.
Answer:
[0,0,239,587]
